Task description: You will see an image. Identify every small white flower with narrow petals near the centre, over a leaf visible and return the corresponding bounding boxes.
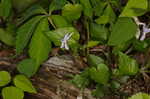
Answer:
[60,33,73,50]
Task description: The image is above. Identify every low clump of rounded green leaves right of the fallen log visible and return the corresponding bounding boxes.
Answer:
[71,52,140,97]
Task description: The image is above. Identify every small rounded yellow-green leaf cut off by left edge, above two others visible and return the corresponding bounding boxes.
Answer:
[0,71,11,86]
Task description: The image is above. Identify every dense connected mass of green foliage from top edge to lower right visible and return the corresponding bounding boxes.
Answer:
[0,0,150,99]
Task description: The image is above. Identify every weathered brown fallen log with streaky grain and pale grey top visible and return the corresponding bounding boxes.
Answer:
[0,55,95,99]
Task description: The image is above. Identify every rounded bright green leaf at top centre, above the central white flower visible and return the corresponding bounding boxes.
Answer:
[62,4,82,22]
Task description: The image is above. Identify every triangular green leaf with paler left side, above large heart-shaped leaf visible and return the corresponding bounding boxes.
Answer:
[95,5,116,24]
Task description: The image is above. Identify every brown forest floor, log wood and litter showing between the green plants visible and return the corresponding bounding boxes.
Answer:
[0,45,150,99]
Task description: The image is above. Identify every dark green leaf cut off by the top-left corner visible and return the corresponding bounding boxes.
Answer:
[0,0,12,19]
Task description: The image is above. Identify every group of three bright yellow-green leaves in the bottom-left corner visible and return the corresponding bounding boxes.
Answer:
[0,71,37,99]
